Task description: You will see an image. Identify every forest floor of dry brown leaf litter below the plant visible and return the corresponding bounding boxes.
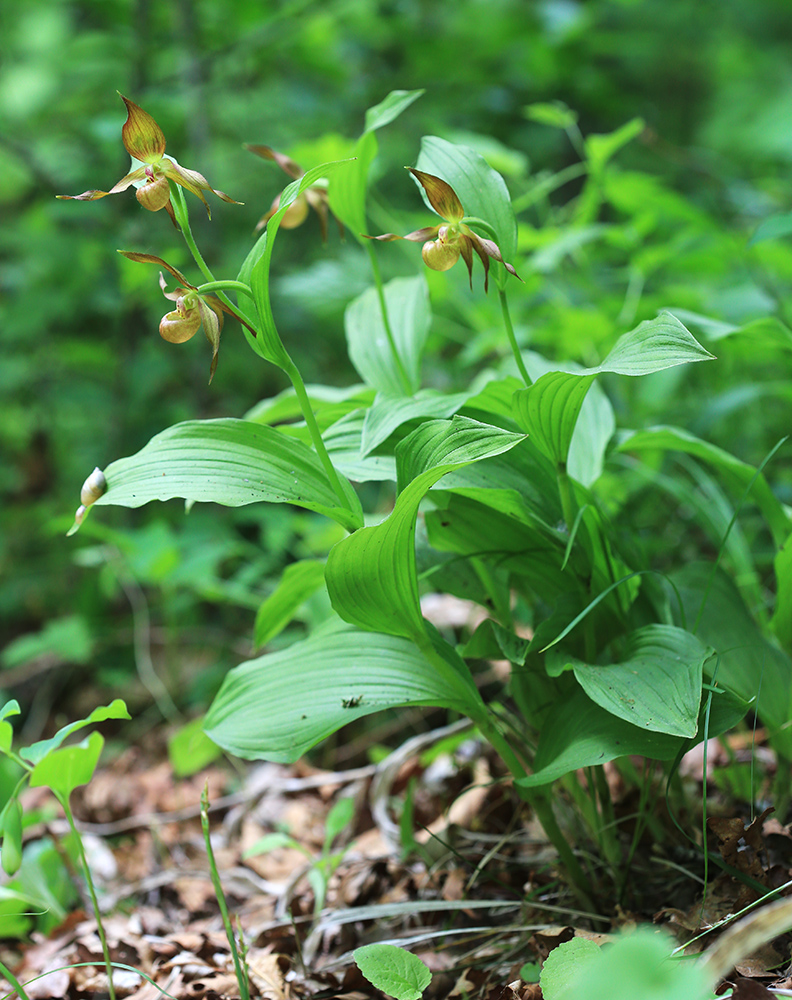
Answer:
[0,726,792,1000]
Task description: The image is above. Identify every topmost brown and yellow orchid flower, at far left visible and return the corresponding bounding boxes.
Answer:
[57,94,241,225]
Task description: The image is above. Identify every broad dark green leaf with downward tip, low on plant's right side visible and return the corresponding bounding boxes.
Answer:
[571,624,714,737]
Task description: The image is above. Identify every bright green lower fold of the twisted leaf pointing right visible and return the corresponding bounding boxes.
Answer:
[514,372,594,466]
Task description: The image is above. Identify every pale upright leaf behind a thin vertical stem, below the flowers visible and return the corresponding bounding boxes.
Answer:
[344,274,432,396]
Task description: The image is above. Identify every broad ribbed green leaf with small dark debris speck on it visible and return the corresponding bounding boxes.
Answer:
[205,626,470,763]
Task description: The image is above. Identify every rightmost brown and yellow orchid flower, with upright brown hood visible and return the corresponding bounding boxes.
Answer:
[366,167,522,292]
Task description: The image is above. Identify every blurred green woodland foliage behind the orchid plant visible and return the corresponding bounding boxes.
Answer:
[0,0,792,724]
